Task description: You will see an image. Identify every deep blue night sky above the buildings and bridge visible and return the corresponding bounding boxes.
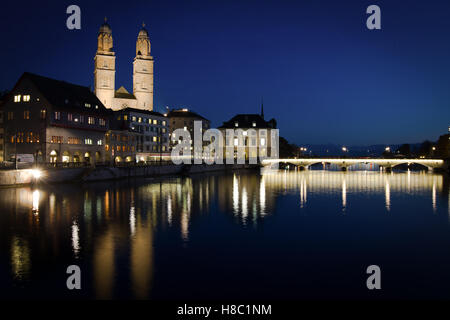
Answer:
[0,0,450,145]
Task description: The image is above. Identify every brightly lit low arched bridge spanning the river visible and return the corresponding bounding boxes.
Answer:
[262,158,445,171]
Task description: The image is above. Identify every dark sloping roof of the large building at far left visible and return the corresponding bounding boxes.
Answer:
[18,72,108,114]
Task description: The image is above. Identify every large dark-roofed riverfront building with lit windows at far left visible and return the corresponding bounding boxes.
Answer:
[2,72,112,164]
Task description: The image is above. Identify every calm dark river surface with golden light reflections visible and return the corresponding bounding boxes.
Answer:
[0,171,450,300]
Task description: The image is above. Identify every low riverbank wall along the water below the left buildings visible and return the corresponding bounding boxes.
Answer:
[0,164,259,186]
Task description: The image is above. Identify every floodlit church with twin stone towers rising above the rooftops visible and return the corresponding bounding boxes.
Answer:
[94,18,154,111]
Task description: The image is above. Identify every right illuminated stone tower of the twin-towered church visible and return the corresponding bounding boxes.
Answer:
[133,24,154,111]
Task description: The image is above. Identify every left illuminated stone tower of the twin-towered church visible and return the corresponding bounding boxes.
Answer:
[94,18,116,108]
